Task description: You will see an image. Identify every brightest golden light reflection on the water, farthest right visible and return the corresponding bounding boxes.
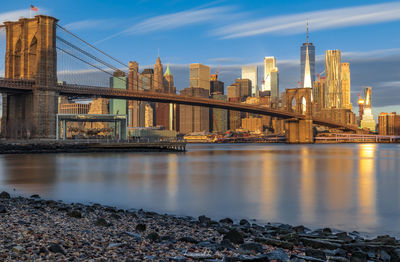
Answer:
[358,144,378,227]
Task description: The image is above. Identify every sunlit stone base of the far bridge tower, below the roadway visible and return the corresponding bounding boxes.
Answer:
[286,119,314,144]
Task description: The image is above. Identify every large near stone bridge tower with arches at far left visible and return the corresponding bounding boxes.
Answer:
[2,15,58,138]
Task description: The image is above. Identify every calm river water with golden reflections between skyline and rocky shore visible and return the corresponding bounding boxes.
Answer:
[0,144,400,236]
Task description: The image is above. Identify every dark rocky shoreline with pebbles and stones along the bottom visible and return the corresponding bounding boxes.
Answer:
[0,192,400,262]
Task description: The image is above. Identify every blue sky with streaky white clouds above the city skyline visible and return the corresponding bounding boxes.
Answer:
[0,0,400,114]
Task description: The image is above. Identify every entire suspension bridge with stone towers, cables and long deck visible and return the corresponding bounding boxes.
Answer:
[0,15,362,143]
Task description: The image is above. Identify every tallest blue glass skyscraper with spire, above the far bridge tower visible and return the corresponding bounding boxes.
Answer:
[300,23,315,88]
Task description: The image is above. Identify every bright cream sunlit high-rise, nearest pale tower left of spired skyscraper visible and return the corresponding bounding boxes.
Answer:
[261,56,279,98]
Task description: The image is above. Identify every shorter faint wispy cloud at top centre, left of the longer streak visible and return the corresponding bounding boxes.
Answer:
[123,6,239,34]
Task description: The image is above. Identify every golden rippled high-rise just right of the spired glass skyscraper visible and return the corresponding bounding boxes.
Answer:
[324,50,343,109]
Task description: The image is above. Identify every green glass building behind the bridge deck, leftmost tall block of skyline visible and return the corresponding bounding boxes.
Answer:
[109,71,128,115]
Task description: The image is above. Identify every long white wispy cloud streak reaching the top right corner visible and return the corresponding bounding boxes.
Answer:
[214,2,400,39]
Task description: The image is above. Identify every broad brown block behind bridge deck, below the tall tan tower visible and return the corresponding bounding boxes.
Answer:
[179,87,210,134]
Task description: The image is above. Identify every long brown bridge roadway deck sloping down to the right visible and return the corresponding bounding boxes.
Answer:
[0,78,359,131]
